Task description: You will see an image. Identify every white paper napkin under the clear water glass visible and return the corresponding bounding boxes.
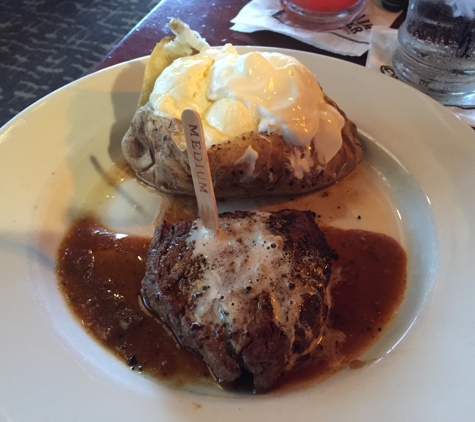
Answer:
[366,26,475,127]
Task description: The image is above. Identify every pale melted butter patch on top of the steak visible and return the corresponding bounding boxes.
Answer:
[189,212,324,365]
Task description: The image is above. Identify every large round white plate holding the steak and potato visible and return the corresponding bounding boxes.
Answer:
[0,47,475,422]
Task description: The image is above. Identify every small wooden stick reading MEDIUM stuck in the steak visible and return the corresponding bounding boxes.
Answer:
[181,108,219,234]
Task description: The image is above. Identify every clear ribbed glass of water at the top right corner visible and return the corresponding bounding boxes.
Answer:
[393,0,475,106]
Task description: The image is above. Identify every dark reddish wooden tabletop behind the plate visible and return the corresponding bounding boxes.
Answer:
[92,0,403,71]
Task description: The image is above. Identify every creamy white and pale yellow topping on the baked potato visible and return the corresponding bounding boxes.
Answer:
[150,44,344,163]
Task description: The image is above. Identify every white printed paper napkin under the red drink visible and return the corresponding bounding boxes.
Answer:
[231,0,401,56]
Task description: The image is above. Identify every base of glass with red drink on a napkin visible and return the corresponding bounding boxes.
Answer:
[280,0,366,31]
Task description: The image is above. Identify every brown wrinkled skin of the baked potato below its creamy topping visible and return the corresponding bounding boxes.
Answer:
[122,97,363,198]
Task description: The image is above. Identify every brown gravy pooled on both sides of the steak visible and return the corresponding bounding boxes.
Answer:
[57,217,406,387]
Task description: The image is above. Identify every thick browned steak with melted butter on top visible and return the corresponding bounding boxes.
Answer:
[142,210,334,391]
